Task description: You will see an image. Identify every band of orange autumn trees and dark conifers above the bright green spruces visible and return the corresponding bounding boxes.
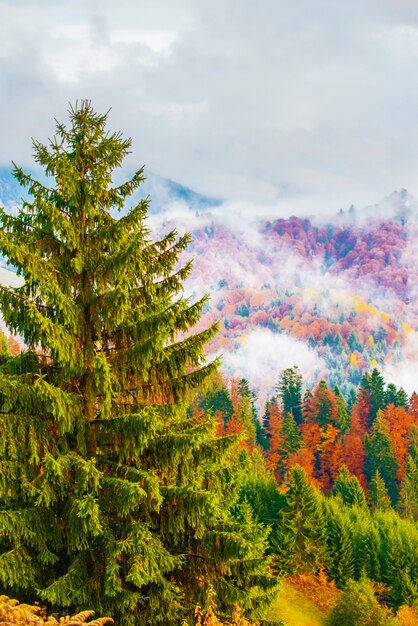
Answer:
[205,367,418,508]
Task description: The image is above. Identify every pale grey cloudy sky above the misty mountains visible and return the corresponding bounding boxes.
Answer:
[0,0,418,213]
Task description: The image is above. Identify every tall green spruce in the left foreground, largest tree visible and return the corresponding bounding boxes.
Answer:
[0,101,273,626]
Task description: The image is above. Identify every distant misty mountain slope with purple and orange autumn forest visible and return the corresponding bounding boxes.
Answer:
[0,171,418,399]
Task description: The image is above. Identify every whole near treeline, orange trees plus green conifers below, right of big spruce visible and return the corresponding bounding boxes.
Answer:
[193,367,418,607]
